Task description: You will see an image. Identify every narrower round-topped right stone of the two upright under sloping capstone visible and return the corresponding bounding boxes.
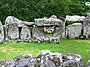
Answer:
[20,26,31,40]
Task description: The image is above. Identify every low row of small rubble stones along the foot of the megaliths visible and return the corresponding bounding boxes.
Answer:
[11,37,60,44]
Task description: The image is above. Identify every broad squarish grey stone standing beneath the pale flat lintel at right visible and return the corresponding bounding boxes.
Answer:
[66,23,82,38]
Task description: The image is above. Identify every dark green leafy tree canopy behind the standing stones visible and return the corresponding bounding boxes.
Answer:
[0,0,90,23]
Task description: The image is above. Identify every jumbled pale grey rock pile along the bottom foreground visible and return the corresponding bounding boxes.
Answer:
[0,50,84,67]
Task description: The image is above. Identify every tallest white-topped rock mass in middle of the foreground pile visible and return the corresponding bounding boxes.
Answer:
[39,50,63,67]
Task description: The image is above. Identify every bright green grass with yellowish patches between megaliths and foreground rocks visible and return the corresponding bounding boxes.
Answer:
[0,40,90,63]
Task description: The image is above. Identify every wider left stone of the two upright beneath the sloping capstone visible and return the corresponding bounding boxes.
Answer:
[7,24,19,39]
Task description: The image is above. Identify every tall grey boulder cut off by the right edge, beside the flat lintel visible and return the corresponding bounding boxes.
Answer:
[83,16,90,39]
